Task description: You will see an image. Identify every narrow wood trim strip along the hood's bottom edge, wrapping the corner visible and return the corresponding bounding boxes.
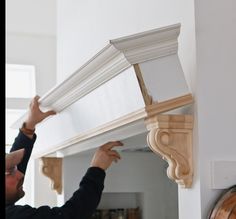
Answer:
[32,94,193,158]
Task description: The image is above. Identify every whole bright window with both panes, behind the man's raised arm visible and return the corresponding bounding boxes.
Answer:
[5,64,36,148]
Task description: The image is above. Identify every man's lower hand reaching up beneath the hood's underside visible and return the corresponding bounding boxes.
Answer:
[91,141,123,170]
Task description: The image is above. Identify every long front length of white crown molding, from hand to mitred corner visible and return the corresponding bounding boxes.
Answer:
[40,48,131,109]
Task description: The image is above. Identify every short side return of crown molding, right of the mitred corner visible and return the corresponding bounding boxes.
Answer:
[110,24,180,64]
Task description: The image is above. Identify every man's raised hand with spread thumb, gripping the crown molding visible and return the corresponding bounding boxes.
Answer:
[25,96,56,130]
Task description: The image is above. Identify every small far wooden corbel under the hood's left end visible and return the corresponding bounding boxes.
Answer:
[41,157,62,194]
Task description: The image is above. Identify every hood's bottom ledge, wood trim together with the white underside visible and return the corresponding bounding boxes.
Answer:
[32,95,193,158]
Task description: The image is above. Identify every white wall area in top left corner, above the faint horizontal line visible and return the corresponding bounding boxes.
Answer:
[5,0,57,37]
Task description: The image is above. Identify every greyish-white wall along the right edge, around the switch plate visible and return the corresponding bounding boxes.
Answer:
[195,0,236,218]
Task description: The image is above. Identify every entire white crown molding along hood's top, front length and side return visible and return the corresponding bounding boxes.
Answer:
[12,24,180,128]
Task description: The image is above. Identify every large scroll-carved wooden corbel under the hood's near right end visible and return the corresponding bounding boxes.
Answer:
[146,115,193,188]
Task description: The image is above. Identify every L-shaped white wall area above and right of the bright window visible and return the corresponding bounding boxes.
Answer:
[6,33,56,96]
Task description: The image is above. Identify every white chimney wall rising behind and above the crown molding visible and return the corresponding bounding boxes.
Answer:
[57,0,195,88]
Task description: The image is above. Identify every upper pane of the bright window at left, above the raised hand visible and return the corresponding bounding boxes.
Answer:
[6,64,36,98]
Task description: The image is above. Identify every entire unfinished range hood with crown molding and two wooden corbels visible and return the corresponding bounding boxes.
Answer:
[14,24,193,193]
